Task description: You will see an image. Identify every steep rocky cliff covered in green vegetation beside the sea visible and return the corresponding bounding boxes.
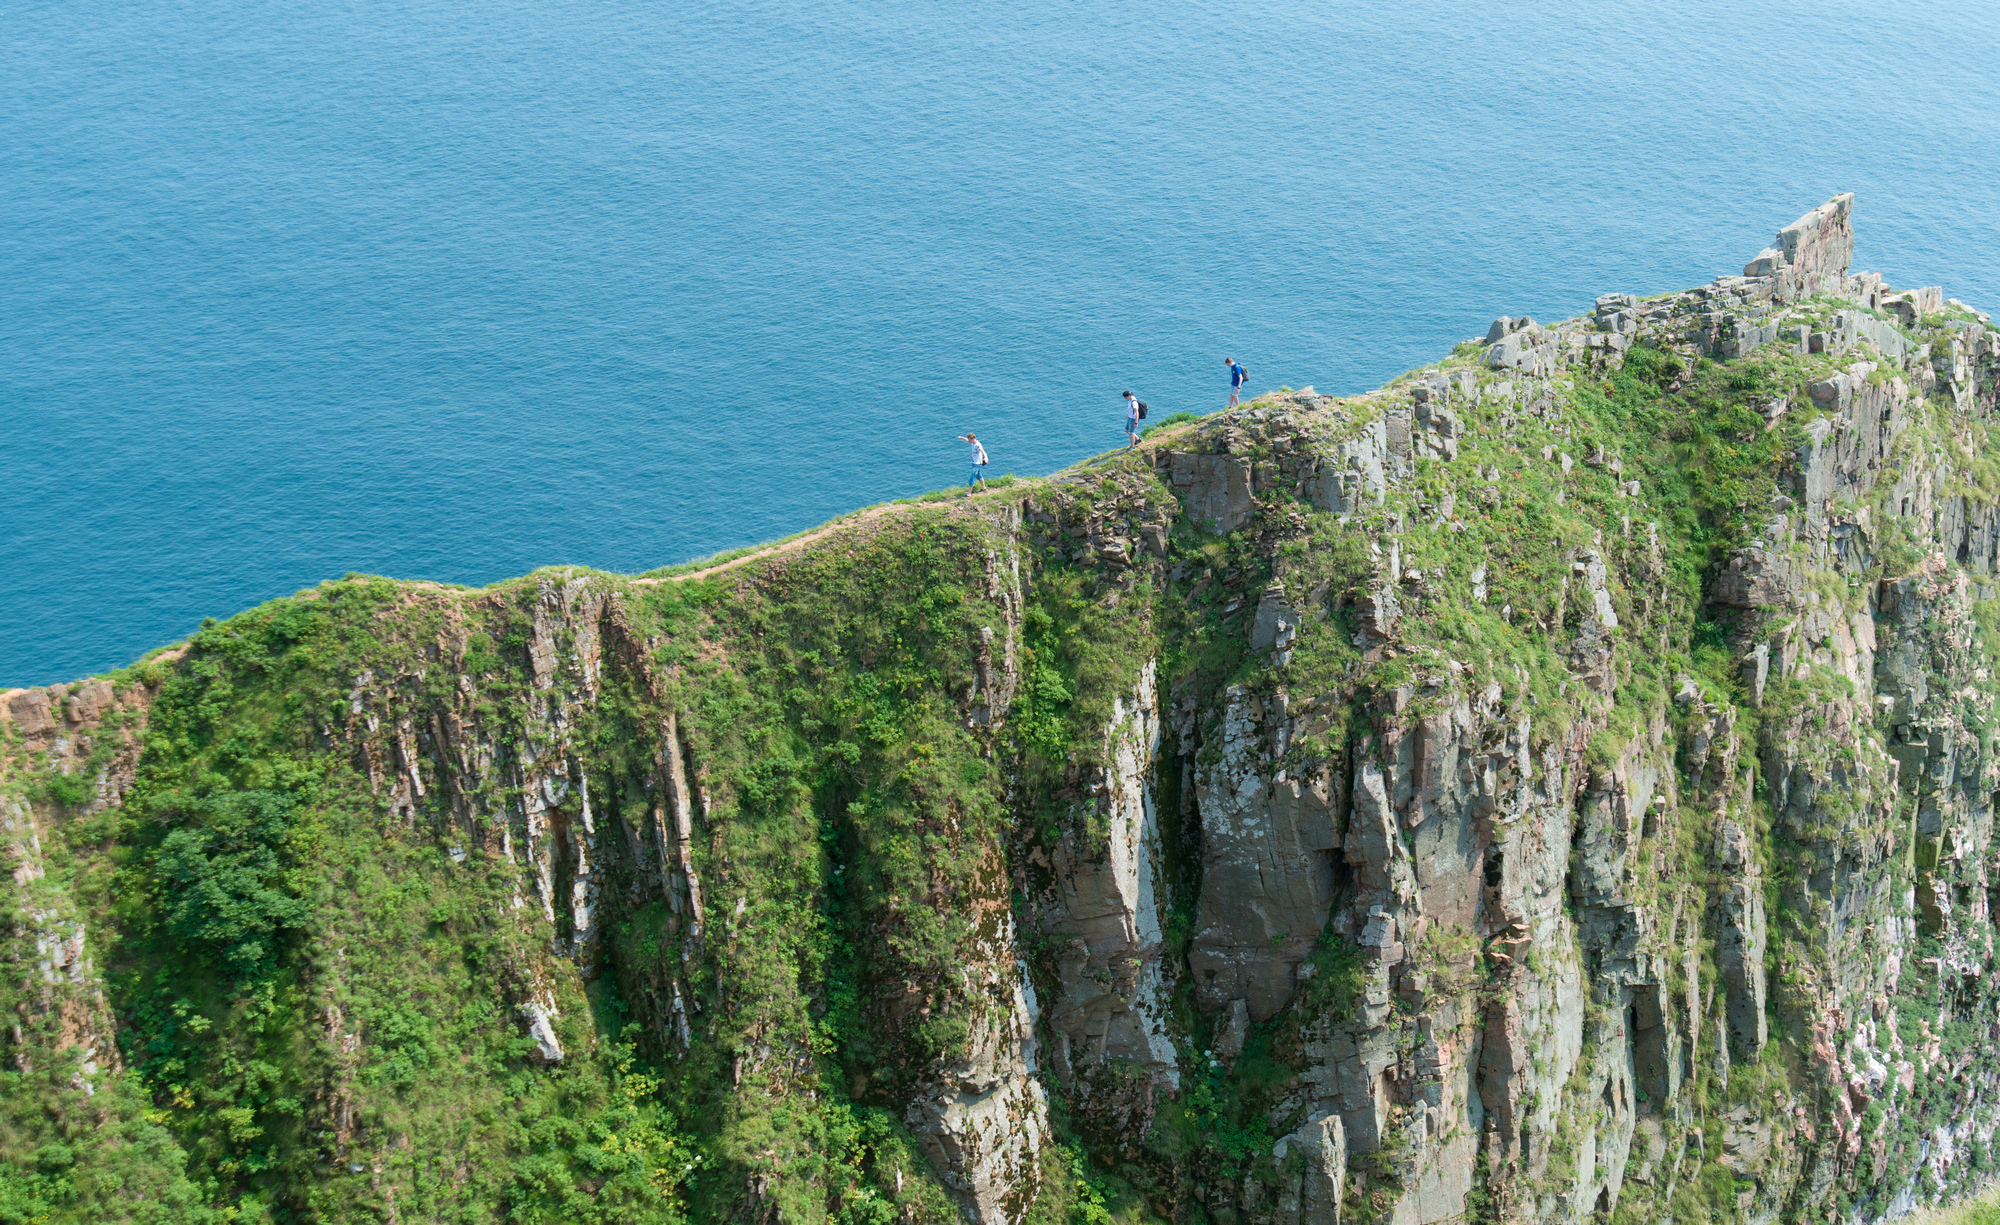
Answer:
[0,196,2000,1225]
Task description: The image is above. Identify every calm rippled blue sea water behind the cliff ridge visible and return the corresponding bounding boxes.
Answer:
[0,0,2000,685]
